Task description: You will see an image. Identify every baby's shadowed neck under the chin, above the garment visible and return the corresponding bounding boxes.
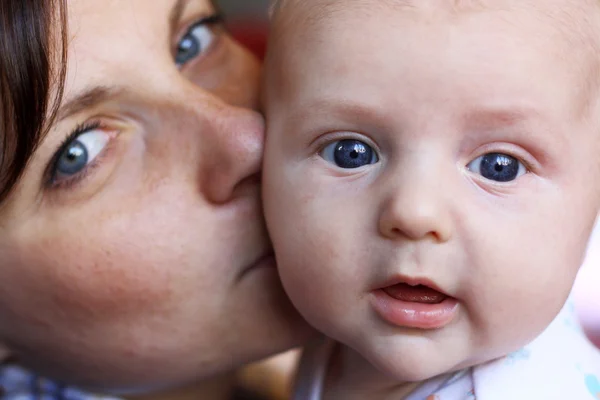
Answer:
[323,344,420,400]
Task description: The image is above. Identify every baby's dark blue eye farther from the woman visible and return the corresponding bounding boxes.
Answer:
[467,153,527,182]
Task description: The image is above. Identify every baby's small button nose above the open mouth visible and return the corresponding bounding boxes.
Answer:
[379,173,452,243]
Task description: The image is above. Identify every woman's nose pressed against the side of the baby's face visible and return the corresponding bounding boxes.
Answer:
[200,106,265,203]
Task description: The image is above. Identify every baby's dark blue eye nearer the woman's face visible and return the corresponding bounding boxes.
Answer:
[321,139,379,169]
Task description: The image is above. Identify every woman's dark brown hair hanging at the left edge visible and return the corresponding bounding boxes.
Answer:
[0,0,67,204]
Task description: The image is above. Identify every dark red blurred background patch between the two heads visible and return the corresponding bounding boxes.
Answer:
[217,0,269,57]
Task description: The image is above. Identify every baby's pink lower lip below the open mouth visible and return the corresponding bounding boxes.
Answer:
[371,289,458,329]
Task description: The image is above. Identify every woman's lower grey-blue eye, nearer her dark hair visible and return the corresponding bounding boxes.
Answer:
[52,129,110,181]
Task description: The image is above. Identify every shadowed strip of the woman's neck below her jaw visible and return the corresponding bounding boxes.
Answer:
[126,374,236,400]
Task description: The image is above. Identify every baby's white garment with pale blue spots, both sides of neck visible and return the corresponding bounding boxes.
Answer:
[293,302,600,400]
